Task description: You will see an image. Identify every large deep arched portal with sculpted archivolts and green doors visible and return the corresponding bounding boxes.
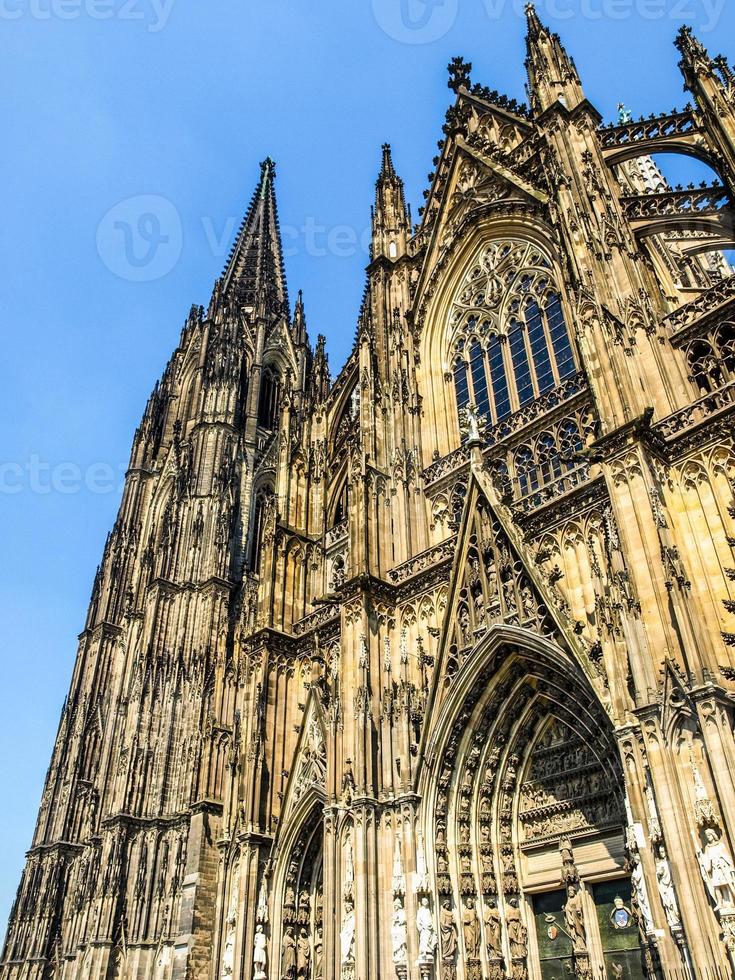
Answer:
[425,627,646,980]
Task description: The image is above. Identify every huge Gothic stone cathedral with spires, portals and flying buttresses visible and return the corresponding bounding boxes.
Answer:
[0,6,735,980]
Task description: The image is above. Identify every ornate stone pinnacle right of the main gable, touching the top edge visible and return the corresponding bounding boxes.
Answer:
[526,3,584,115]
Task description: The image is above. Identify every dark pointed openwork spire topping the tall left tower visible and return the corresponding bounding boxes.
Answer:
[222,157,288,315]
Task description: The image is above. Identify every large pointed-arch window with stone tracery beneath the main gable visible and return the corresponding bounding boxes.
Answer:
[450,235,577,434]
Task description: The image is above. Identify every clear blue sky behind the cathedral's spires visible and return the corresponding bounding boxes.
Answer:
[0,0,735,931]
